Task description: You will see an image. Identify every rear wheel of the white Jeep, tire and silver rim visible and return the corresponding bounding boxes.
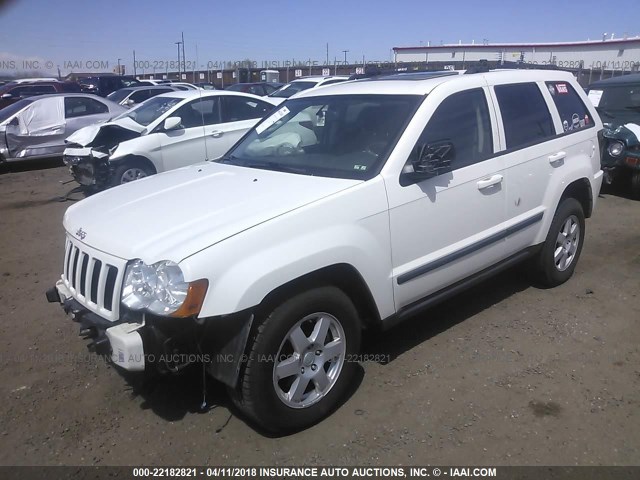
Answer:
[532,198,585,287]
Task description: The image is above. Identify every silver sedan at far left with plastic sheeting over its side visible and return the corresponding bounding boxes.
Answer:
[0,93,126,163]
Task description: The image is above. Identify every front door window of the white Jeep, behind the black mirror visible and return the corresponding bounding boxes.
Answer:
[409,88,493,170]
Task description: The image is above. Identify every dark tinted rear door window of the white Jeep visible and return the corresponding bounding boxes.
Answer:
[495,83,555,150]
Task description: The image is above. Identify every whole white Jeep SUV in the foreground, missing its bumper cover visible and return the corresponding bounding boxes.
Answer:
[47,71,602,431]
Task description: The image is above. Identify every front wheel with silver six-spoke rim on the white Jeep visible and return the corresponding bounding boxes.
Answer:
[232,286,361,432]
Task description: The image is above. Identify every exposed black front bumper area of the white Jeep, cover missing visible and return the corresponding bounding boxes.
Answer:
[46,280,253,387]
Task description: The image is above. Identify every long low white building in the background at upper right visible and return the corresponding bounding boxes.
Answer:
[393,37,640,72]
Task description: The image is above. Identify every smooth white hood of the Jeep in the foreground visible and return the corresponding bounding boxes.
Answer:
[64,163,362,263]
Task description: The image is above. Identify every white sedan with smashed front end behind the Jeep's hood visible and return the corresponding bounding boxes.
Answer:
[63,90,274,189]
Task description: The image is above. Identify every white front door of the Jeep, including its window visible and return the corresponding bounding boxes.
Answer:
[387,88,505,310]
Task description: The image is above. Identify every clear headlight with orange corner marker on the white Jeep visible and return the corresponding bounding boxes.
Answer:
[122,260,208,317]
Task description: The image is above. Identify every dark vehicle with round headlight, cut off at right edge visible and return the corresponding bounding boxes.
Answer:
[588,74,640,200]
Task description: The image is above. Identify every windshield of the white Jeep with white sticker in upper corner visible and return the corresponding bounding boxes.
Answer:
[217,95,425,180]
